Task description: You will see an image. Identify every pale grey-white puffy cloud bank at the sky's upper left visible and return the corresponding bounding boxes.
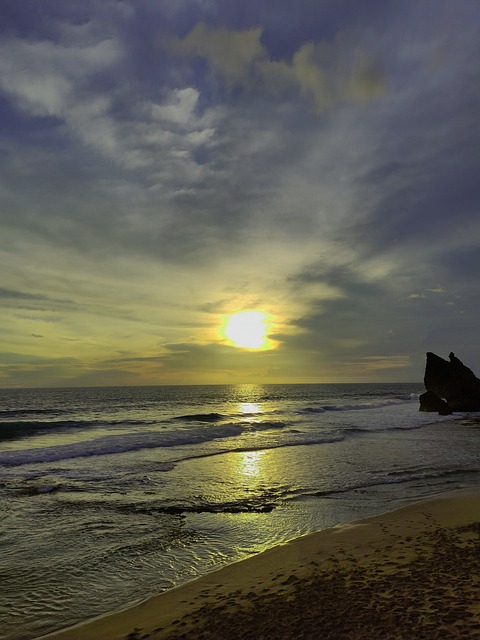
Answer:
[0,12,221,195]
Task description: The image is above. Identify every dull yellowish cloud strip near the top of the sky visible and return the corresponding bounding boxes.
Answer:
[176,23,385,111]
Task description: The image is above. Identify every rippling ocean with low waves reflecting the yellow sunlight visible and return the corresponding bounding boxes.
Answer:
[0,383,480,640]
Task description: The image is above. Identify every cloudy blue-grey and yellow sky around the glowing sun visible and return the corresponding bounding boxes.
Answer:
[0,0,480,387]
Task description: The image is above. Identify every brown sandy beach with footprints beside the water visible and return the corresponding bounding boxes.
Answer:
[41,492,480,640]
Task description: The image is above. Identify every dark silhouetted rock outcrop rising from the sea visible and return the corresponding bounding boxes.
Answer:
[420,351,480,415]
